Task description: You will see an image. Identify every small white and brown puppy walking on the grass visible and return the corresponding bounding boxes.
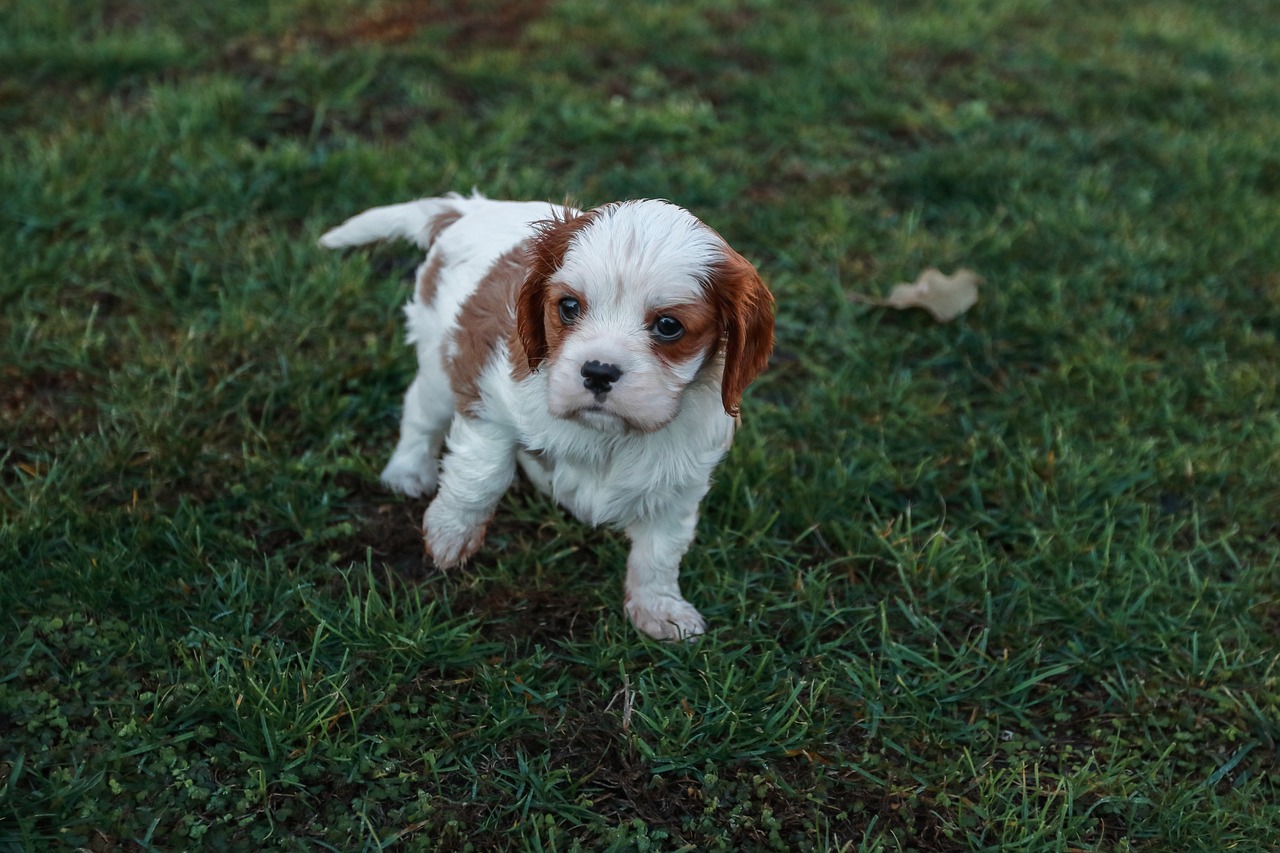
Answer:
[320,193,773,639]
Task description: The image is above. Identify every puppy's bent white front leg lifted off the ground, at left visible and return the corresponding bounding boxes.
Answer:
[422,415,516,569]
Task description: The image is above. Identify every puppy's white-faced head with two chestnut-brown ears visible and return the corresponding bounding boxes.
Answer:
[516,200,773,433]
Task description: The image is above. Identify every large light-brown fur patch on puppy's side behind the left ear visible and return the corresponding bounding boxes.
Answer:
[445,245,527,412]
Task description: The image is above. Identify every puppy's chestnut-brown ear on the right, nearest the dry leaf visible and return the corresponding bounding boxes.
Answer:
[708,245,773,416]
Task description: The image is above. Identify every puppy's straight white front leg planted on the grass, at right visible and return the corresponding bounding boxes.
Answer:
[623,501,707,639]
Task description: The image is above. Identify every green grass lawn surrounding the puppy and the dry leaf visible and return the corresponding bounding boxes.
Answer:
[0,0,1280,852]
